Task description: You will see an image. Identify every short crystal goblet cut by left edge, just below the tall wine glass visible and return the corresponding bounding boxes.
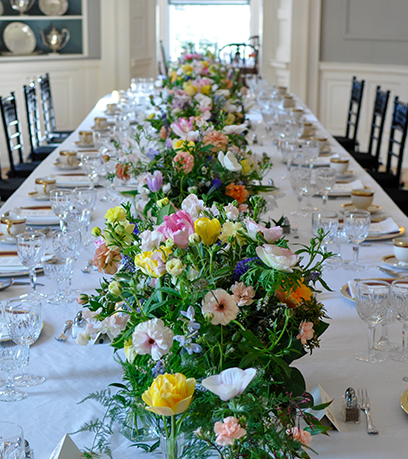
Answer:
[0,341,28,402]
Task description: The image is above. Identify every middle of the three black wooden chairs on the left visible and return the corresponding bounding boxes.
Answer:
[23,81,56,161]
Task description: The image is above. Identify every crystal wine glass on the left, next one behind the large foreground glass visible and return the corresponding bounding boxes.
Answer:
[16,232,46,298]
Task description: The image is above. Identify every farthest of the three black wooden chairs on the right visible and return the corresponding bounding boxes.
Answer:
[334,76,365,152]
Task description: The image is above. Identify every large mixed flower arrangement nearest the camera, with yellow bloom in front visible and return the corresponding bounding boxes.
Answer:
[78,194,334,459]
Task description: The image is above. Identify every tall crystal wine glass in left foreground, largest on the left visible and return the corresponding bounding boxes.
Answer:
[4,299,45,387]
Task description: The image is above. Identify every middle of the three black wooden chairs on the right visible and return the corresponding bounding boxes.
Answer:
[351,86,390,171]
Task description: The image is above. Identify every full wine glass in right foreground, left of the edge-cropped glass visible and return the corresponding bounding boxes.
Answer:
[354,280,390,363]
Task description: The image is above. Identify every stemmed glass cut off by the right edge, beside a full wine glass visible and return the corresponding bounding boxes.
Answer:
[390,280,408,362]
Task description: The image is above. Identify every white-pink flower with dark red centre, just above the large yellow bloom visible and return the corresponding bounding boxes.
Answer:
[132,319,174,360]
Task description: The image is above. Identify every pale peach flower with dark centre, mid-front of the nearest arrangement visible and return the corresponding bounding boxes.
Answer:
[201,288,239,325]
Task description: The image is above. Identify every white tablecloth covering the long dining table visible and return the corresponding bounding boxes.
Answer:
[0,91,408,459]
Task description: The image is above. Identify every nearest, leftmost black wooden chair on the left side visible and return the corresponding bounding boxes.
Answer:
[0,92,40,178]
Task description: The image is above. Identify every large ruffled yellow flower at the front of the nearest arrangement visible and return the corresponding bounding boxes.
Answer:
[142,373,196,416]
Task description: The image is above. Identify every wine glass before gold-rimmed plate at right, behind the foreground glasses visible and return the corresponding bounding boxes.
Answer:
[344,210,371,271]
